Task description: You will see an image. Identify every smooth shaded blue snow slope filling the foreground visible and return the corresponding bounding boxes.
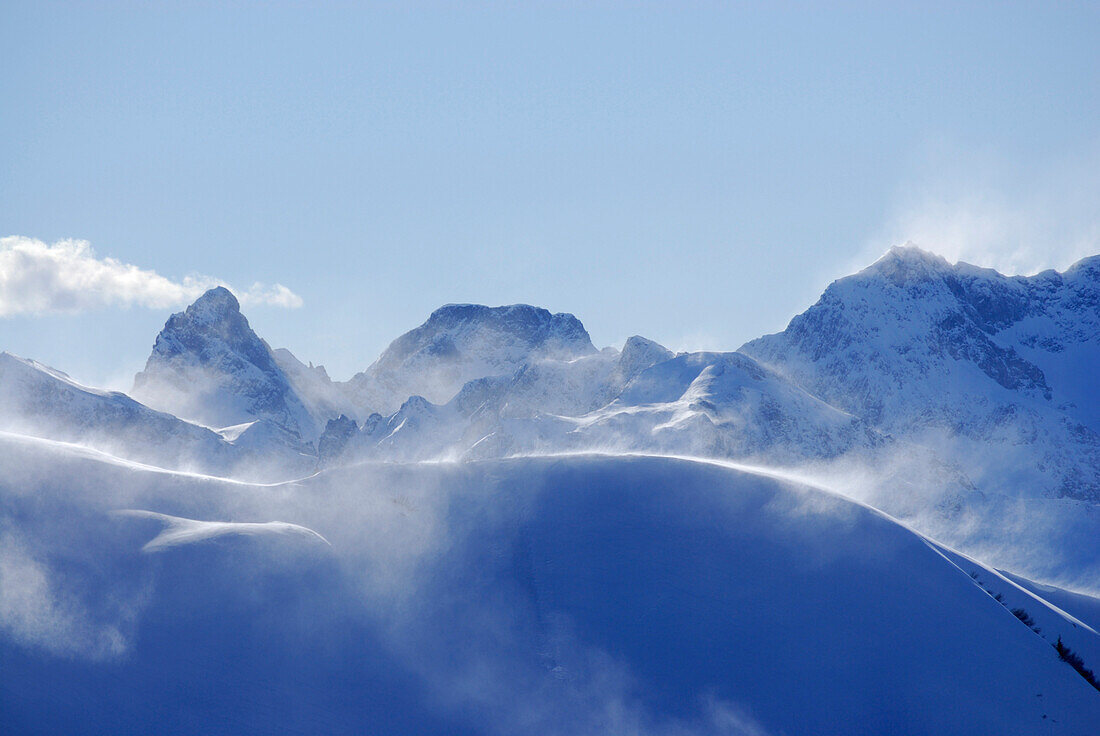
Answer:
[0,444,1100,736]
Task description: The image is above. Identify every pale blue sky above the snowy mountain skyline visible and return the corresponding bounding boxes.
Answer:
[0,0,1100,387]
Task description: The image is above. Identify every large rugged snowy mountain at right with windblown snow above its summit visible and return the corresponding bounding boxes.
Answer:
[741,246,1100,501]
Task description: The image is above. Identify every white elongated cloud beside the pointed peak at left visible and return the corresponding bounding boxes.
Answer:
[0,235,301,317]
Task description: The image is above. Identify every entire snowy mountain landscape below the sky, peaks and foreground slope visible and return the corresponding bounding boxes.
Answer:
[0,245,1100,736]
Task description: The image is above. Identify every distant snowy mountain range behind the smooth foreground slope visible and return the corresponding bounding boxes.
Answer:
[0,245,1100,586]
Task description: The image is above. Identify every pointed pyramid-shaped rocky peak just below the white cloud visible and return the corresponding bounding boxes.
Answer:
[133,286,317,439]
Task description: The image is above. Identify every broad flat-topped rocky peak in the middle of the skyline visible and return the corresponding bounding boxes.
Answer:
[349,305,596,414]
